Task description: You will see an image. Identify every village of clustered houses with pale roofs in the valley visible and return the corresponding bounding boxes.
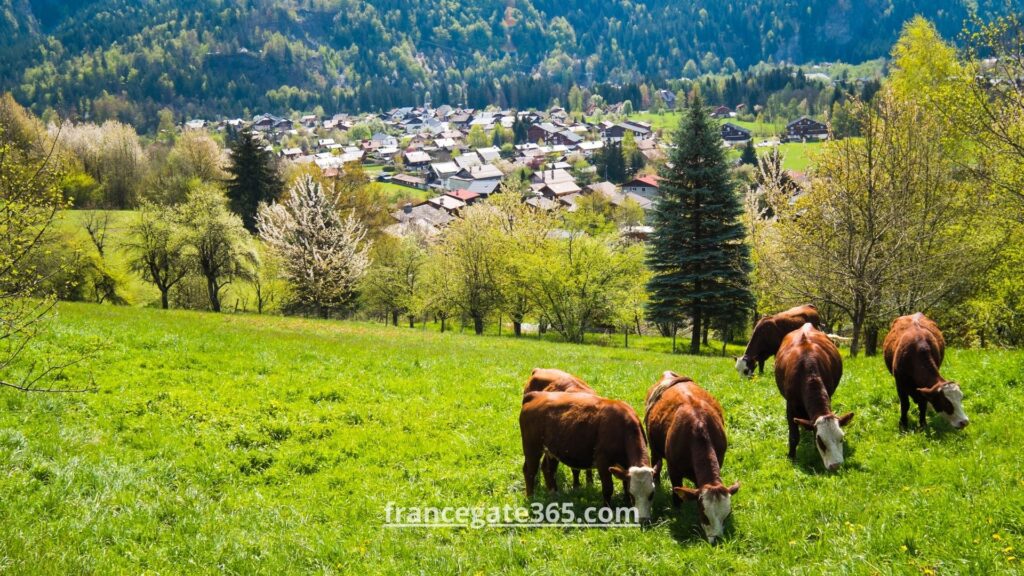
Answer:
[183,99,830,240]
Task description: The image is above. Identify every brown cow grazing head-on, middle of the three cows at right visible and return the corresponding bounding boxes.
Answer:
[775,323,853,470]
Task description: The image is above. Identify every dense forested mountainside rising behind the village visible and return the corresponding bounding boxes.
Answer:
[0,0,1002,127]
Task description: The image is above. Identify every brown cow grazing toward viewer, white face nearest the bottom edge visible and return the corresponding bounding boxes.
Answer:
[644,372,739,543]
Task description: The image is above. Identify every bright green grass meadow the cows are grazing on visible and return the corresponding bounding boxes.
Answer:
[0,304,1024,575]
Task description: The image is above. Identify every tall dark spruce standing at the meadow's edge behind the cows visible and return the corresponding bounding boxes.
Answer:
[647,98,754,354]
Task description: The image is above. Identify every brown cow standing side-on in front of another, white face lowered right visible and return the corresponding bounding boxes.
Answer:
[519,392,654,522]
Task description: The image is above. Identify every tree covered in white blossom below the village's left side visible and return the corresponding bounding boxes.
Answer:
[256,176,371,318]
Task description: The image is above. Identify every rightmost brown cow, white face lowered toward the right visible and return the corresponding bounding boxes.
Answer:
[882,313,970,429]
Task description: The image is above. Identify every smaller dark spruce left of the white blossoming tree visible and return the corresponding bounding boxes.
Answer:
[227,130,285,232]
